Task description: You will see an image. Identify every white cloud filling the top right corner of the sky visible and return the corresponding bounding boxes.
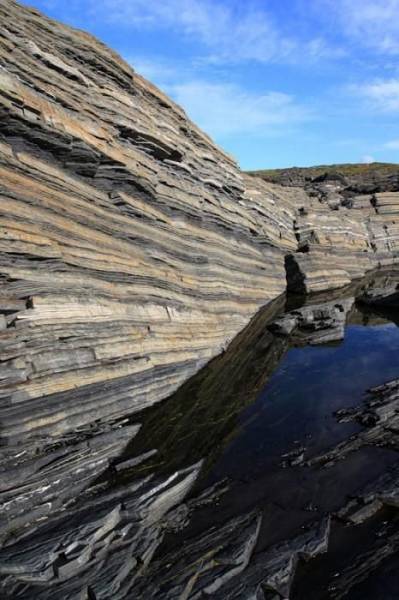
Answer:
[324,0,399,55]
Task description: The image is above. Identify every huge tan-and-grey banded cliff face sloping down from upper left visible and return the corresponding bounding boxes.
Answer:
[0,0,296,450]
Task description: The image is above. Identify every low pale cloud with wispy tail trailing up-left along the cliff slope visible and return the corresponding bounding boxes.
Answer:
[129,57,316,140]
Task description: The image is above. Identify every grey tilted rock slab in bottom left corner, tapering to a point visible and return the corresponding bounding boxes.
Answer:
[0,464,200,600]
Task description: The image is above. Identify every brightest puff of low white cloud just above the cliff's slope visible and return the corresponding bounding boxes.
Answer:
[166,80,312,138]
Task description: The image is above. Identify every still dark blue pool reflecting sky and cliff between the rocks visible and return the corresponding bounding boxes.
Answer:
[122,298,399,600]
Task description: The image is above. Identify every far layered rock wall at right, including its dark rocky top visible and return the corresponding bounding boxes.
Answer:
[255,165,399,292]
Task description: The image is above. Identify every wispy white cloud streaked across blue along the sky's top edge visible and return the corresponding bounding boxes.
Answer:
[90,0,342,63]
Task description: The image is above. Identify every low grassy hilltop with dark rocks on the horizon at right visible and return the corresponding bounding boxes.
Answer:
[250,162,399,191]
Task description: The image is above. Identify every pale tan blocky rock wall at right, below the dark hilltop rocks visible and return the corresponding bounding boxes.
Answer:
[287,184,399,292]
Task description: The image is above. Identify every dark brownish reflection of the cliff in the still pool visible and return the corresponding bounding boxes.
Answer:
[120,292,289,480]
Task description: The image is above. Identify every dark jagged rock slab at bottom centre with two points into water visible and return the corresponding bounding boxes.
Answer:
[134,513,330,600]
